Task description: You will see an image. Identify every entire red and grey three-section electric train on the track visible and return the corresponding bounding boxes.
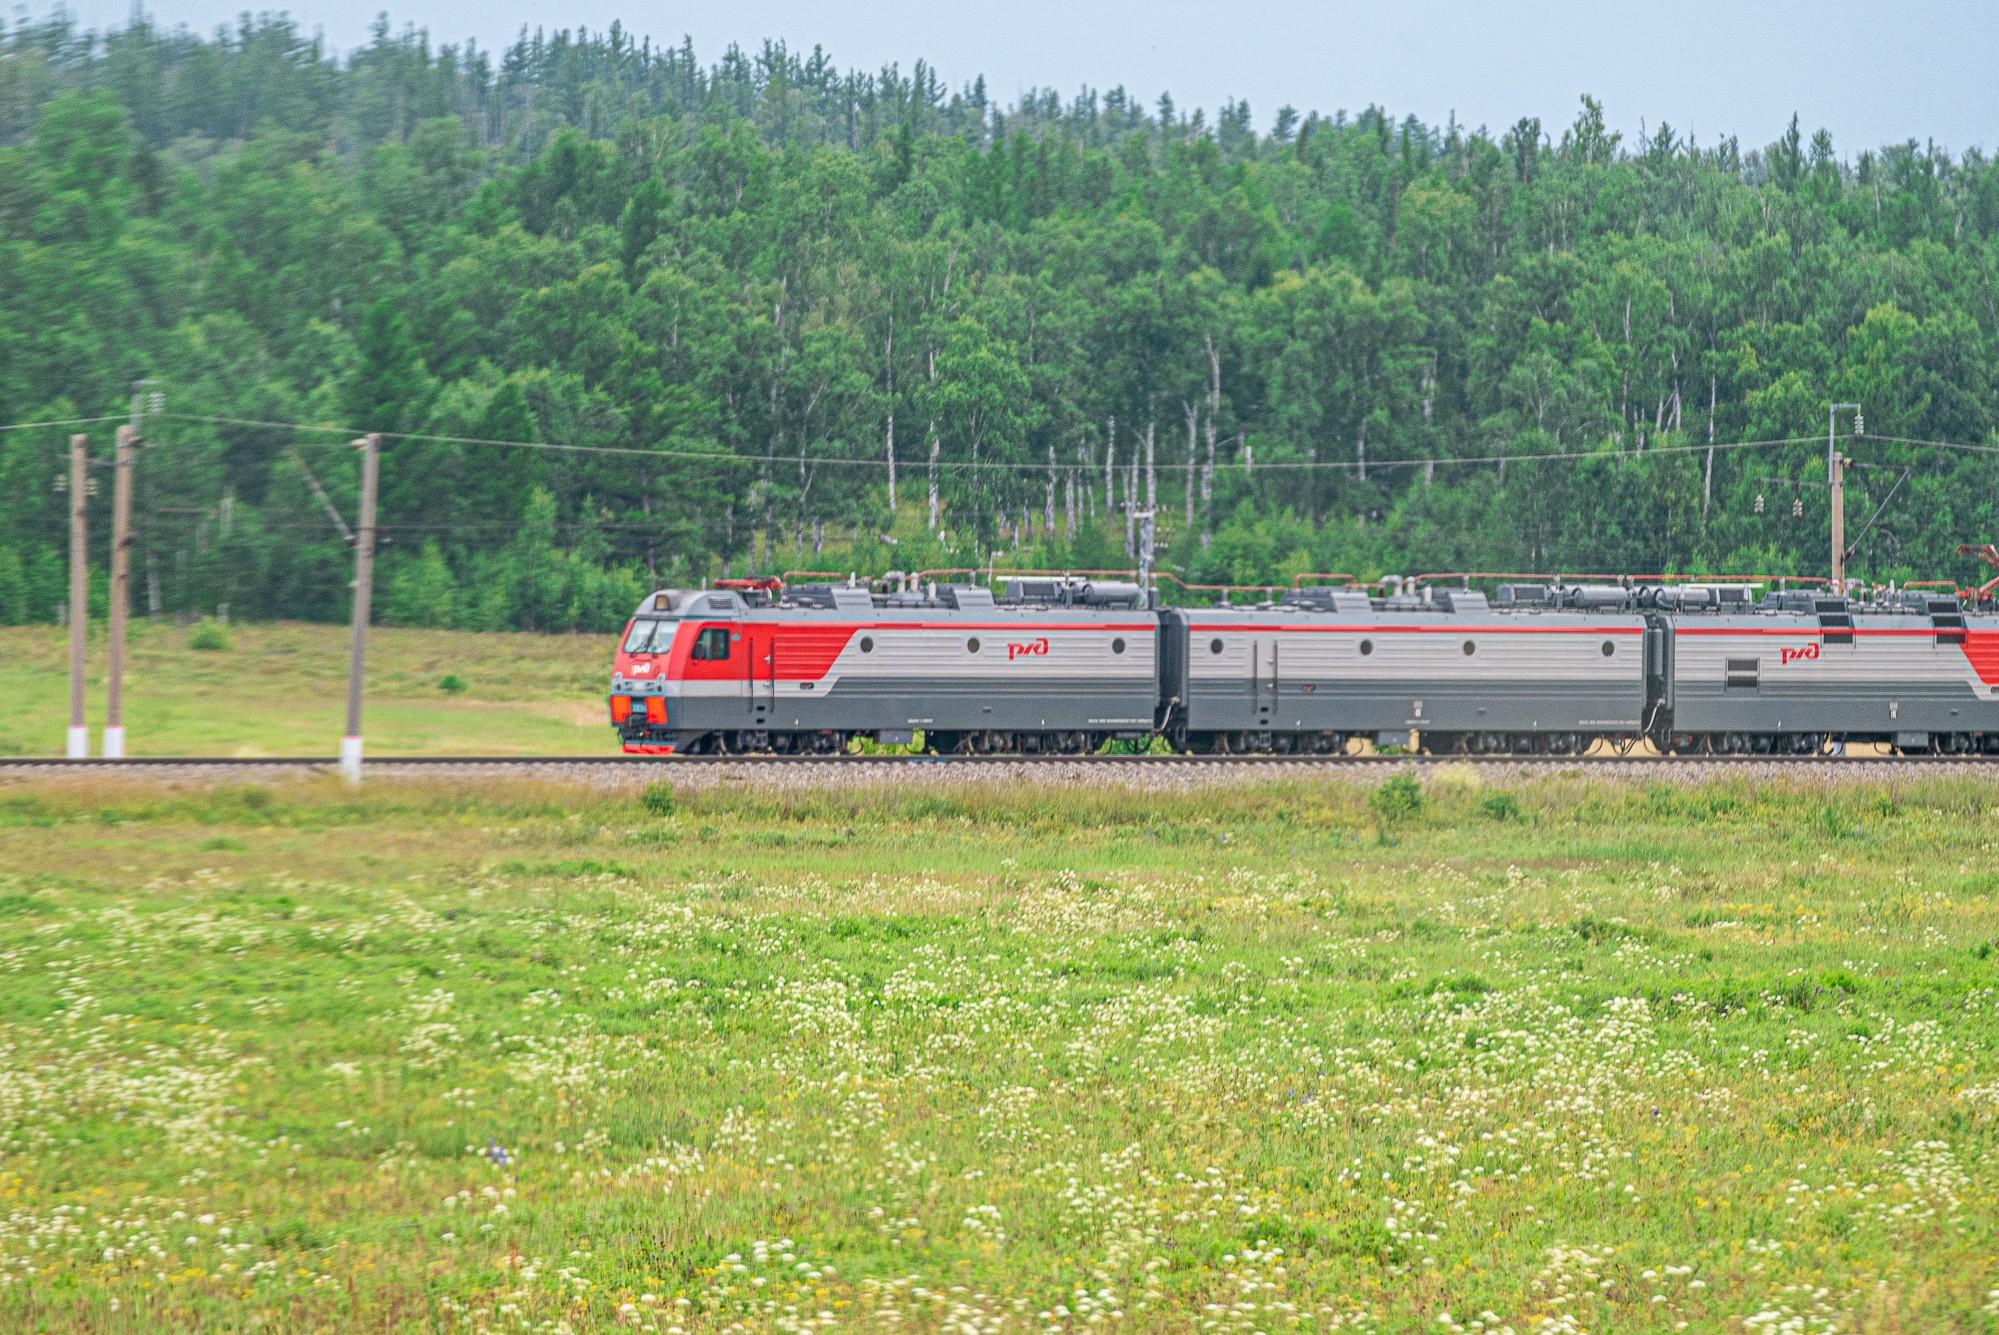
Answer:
[612,580,1999,755]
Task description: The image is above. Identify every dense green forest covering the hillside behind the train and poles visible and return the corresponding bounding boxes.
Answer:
[0,18,1999,628]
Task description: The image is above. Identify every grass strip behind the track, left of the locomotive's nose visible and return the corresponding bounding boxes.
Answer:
[0,618,618,755]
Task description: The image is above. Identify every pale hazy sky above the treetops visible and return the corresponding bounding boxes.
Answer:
[31,0,1999,156]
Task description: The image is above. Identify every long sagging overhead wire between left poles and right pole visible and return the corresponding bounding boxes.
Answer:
[162,412,1839,474]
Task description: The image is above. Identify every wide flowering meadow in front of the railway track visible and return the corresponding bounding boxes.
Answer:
[0,769,1999,1333]
